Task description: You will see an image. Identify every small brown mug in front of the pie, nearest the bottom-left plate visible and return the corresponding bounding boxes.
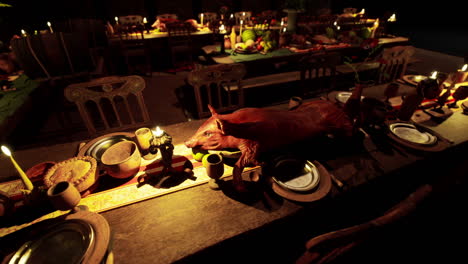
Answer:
[47,181,81,211]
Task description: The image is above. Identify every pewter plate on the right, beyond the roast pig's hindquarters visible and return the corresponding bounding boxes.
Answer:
[390,123,437,145]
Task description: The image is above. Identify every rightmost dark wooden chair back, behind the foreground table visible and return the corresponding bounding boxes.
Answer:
[376,46,415,83]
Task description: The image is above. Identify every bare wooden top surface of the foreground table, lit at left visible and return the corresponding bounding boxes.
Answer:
[0,92,468,263]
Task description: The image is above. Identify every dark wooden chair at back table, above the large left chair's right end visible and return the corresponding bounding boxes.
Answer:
[119,24,153,76]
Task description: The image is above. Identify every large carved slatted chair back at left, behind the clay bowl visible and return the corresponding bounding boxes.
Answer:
[64,75,150,136]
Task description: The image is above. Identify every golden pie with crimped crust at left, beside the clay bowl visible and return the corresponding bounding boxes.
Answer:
[44,156,97,192]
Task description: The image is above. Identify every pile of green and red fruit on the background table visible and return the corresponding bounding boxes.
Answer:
[234,29,278,53]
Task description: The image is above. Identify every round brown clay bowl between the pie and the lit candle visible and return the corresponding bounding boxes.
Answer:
[101,141,141,179]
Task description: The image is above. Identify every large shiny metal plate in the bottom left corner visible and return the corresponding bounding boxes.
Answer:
[8,219,94,264]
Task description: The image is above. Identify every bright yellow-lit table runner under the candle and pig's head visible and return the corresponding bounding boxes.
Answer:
[0,144,254,237]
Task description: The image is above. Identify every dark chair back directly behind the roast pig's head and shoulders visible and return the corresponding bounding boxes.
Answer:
[187,63,246,118]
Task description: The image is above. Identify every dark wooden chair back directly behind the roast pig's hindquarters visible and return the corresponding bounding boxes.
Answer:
[299,52,341,97]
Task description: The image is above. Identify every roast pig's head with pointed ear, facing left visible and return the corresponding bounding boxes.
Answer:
[185,105,230,150]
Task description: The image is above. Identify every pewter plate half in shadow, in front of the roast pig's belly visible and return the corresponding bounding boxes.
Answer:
[272,159,320,192]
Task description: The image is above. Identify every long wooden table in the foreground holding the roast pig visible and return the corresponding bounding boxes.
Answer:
[0,89,468,263]
